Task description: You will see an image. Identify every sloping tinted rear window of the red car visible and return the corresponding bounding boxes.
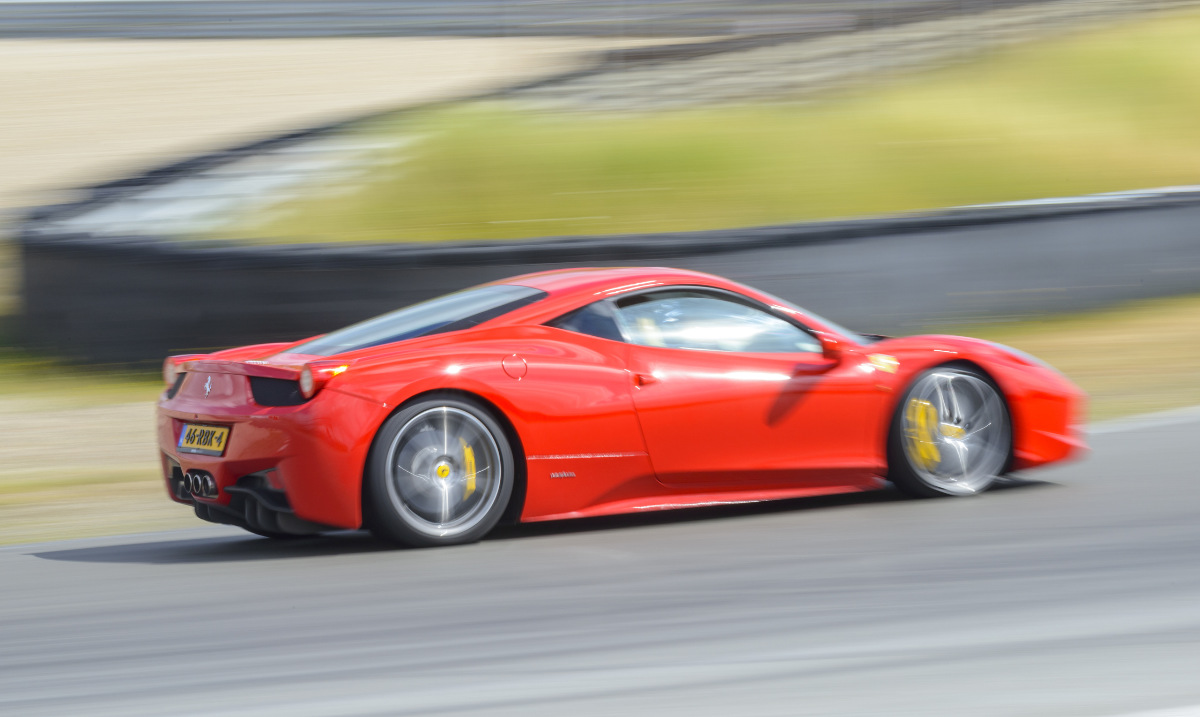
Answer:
[288,284,546,356]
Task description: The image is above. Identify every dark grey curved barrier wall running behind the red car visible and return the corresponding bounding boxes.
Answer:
[18,177,1200,362]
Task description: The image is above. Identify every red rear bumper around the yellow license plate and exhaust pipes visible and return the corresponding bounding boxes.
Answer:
[157,390,385,532]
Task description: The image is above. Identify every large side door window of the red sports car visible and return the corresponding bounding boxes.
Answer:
[617,290,821,354]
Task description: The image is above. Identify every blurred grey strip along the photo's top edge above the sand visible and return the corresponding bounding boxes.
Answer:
[0,0,1045,37]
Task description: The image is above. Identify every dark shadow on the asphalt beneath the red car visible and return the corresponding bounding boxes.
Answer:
[30,480,1056,565]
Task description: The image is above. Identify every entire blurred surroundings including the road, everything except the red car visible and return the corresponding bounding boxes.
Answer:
[11,5,1200,717]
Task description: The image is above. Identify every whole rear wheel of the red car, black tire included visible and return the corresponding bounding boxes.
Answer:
[362,394,516,547]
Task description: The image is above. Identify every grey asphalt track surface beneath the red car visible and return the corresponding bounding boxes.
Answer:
[0,411,1200,717]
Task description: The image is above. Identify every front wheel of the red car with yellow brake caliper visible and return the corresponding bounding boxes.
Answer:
[888,366,1013,498]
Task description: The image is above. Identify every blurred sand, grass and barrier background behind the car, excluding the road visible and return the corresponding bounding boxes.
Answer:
[0,0,1200,543]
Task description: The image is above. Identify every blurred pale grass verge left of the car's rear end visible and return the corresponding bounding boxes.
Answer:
[0,348,189,544]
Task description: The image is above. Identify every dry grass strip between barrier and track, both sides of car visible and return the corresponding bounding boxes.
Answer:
[0,296,1200,544]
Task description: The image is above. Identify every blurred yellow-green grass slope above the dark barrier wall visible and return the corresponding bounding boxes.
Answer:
[229,8,1200,241]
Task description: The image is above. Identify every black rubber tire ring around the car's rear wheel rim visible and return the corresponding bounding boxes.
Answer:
[362,396,516,547]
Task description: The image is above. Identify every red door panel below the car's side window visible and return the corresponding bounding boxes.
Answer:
[630,347,877,487]
